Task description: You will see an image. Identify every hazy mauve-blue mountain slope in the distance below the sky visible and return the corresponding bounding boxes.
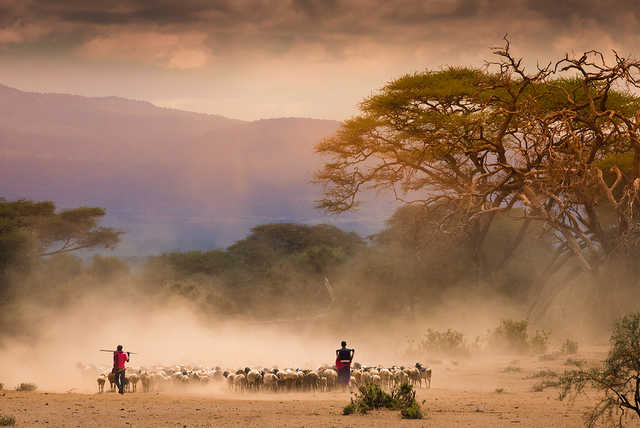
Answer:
[0,85,391,255]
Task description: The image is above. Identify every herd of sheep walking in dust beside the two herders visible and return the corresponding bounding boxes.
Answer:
[79,363,431,392]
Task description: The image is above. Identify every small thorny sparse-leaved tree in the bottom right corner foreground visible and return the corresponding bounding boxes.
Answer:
[560,313,640,427]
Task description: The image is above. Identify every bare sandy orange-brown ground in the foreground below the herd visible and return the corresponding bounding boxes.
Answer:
[0,348,640,427]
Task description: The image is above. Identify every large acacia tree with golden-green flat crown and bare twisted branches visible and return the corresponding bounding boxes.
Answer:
[316,40,640,300]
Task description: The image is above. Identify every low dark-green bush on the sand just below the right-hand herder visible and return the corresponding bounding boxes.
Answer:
[342,383,422,419]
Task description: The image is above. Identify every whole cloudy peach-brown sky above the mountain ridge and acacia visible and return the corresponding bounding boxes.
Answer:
[0,0,640,120]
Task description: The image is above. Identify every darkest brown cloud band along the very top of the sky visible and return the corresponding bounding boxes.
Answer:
[6,0,640,47]
